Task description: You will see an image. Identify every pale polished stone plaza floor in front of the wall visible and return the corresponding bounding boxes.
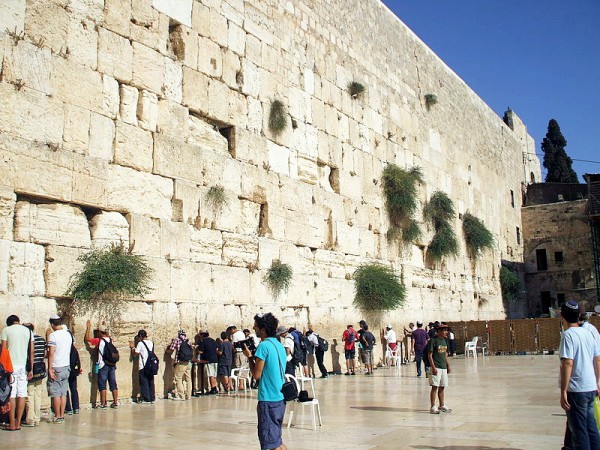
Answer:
[0,355,565,450]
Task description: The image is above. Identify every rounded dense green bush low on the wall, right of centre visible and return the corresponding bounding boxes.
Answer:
[353,264,406,311]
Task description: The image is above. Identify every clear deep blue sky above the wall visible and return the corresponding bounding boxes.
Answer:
[383,0,600,182]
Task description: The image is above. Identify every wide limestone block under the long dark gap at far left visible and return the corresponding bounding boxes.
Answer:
[15,201,91,248]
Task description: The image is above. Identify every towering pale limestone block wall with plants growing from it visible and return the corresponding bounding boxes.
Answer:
[0,0,540,394]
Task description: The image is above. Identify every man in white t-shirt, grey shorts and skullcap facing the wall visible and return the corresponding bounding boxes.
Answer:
[48,315,73,424]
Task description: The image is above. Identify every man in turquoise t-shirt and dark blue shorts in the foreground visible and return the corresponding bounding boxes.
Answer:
[244,313,287,450]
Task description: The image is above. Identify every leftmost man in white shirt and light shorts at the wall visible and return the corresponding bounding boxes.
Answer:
[0,315,34,431]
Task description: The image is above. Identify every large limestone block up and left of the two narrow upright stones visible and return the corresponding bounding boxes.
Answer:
[51,56,104,113]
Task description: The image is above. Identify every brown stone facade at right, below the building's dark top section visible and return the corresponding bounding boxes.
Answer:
[522,200,597,313]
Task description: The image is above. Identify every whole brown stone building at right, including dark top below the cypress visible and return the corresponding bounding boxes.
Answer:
[522,183,597,315]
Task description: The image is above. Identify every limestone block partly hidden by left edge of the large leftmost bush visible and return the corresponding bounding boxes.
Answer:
[45,245,85,298]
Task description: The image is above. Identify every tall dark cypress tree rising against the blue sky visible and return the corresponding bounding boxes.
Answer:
[542,119,579,183]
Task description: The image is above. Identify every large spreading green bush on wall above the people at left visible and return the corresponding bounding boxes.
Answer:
[65,242,153,321]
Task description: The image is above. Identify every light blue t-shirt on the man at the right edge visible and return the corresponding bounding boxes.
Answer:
[558,327,600,392]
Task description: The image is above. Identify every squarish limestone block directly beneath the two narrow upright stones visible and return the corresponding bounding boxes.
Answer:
[114,122,154,172]
